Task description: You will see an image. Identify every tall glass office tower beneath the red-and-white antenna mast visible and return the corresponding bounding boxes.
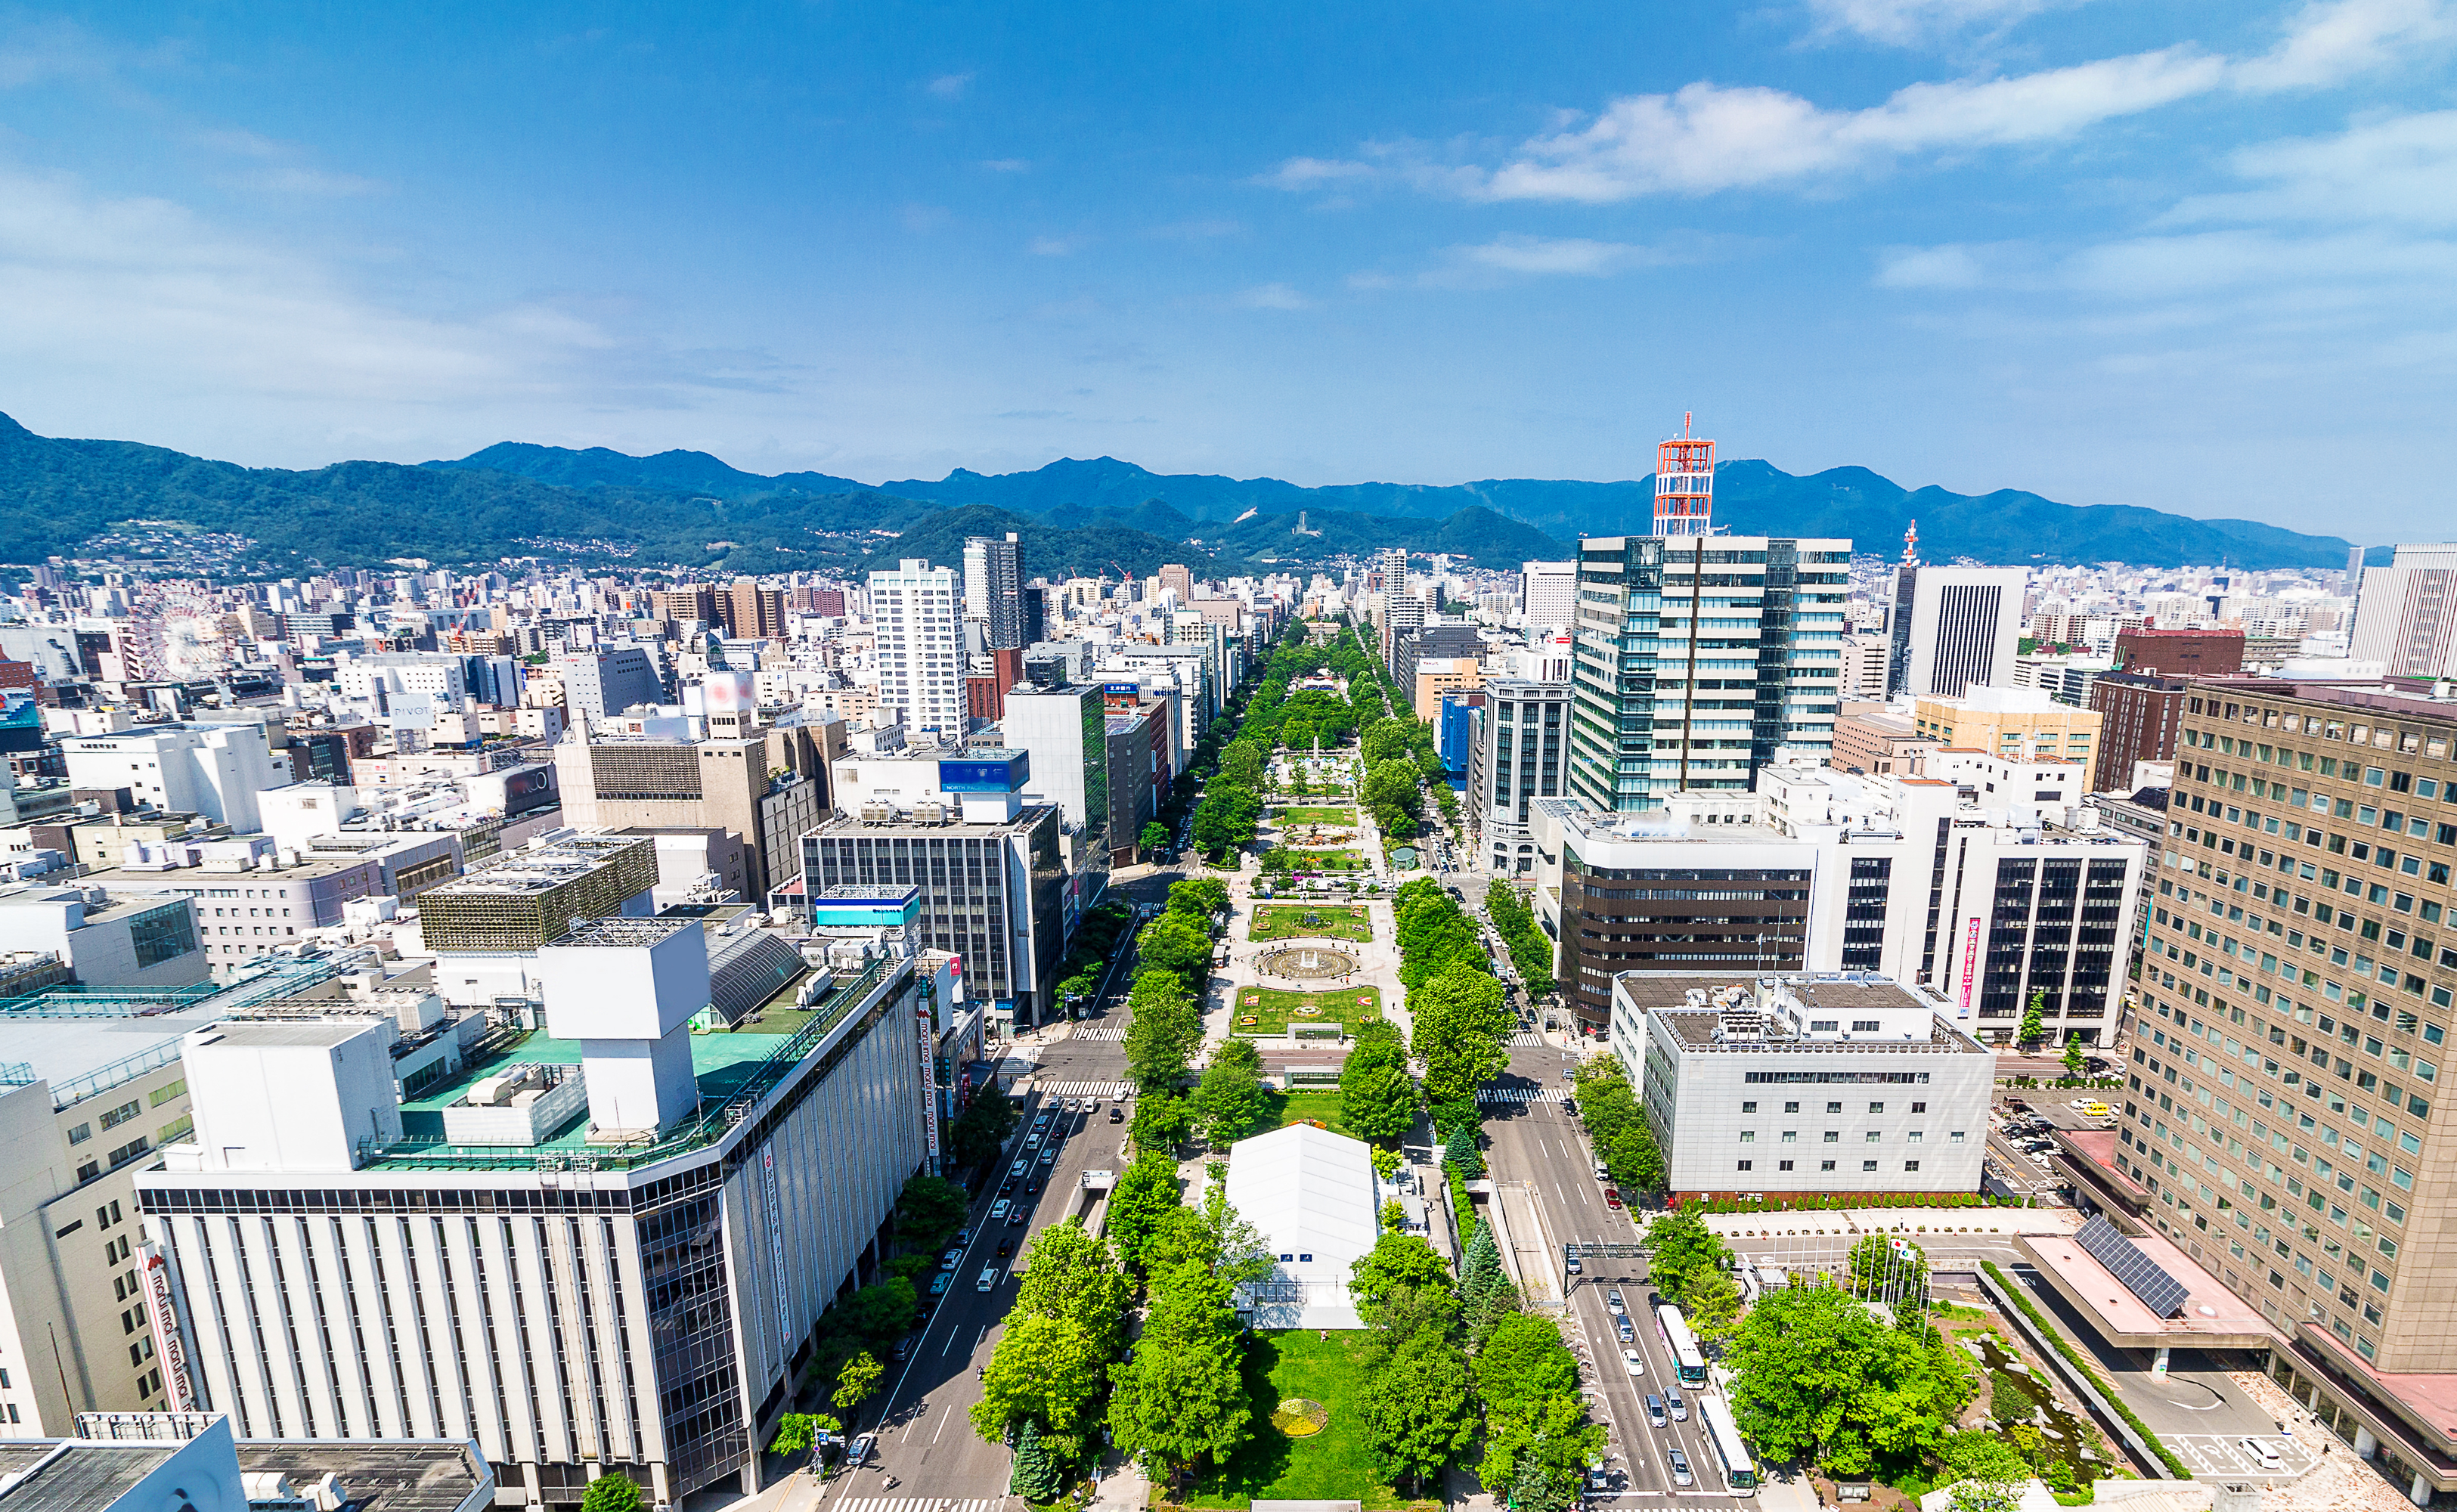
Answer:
[1570,536,1850,811]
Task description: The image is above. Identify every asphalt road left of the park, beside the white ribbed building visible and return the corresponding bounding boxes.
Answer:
[850,870,1187,1502]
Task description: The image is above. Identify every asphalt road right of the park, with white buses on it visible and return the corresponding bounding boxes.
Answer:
[1484,1047,1730,1497]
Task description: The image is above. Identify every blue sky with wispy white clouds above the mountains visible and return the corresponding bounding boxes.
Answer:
[0,0,2457,541]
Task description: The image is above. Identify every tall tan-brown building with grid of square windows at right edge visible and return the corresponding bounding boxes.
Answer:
[2115,679,2457,1502]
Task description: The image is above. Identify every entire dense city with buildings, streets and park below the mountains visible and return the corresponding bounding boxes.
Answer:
[0,423,2457,1512]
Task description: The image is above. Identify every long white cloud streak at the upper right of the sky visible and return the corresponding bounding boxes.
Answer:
[1260,0,2457,204]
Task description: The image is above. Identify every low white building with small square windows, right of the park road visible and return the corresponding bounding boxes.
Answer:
[1612,971,1995,1198]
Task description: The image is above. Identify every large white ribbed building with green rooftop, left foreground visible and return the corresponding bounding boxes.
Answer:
[138,905,953,1504]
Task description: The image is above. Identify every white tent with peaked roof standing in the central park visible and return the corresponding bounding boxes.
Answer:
[1228,1123,1378,1328]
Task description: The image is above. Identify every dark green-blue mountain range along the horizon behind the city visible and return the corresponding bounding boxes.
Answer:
[0,416,2386,575]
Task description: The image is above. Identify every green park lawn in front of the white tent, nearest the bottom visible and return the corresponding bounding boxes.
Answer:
[1185,1328,1408,1512]
